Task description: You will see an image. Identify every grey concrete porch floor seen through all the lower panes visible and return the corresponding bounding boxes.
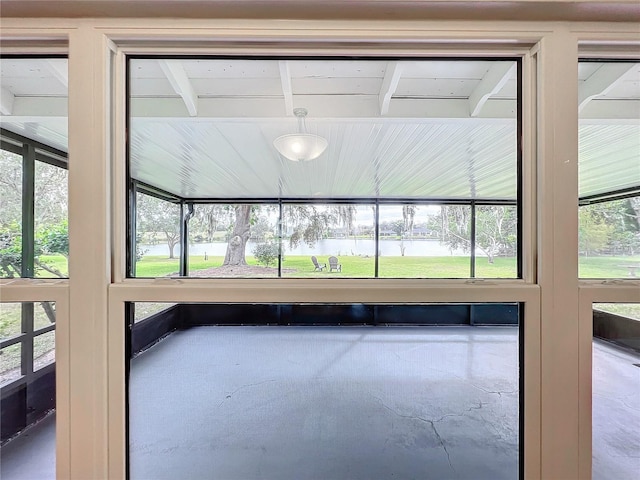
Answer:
[0,327,640,480]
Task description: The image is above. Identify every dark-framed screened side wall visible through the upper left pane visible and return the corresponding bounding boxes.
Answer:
[0,133,69,278]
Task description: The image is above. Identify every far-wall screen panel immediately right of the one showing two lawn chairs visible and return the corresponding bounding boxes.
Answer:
[378,205,471,278]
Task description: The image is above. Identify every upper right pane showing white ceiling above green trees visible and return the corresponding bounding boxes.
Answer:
[578,61,640,279]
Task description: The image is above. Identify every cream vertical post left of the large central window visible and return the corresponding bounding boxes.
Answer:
[69,25,111,479]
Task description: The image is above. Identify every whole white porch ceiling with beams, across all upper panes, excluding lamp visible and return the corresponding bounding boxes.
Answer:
[0,58,640,199]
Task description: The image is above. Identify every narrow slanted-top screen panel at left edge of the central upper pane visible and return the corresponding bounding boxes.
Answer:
[135,193,180,277]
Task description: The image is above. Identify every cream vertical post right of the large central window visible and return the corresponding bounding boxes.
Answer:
[538,25,580,479]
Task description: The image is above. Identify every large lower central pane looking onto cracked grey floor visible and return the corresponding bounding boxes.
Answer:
[128,304,520,480]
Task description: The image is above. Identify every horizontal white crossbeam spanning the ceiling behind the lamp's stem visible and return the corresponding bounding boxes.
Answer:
[0,93,640,124]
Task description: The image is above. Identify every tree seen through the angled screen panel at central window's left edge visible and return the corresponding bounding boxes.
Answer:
[136,193,180,258]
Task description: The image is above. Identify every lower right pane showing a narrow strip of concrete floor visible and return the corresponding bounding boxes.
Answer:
[592,303,640,480]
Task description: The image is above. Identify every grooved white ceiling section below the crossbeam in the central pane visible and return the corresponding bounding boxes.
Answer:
[131,119,516,199]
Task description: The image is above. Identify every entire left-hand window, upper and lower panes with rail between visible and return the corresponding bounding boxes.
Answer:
[0,55,69,478]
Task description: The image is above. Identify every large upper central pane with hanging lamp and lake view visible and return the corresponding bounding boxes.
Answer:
[128,57,522,278]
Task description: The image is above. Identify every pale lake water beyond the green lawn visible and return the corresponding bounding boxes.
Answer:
[140,238,465,257]
